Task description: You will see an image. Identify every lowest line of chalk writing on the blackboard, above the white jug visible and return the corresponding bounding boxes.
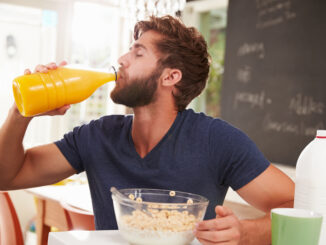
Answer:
[262,114,325,137]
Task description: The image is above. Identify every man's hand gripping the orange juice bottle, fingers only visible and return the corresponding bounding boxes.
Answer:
[13,61,70,116]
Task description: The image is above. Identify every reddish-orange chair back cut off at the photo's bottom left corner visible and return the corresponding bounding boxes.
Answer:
[0,192,24,245]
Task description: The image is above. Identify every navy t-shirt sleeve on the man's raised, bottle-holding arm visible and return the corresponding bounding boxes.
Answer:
[55,125,86,173]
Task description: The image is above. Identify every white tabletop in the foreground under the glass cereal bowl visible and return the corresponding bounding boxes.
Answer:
[48,230,200,245]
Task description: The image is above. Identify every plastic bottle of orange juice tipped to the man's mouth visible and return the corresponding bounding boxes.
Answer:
[12,67,118,117]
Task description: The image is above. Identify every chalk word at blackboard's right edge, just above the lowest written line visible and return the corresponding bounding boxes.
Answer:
[289,93,325,116]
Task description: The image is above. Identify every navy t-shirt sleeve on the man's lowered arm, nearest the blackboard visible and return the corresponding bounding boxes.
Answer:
[210,120,270,190]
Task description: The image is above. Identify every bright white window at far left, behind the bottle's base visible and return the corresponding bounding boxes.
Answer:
[0,3,57,146]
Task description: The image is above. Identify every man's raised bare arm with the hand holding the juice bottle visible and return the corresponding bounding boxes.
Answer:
[0,60,75,190]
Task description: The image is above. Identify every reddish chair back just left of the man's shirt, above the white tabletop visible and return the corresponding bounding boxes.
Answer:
[61,202,95,230]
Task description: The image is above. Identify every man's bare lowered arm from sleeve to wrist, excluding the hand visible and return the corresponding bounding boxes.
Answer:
[237,165,294,244]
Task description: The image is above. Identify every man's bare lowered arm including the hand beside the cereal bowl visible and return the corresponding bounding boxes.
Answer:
[195,165,294,245]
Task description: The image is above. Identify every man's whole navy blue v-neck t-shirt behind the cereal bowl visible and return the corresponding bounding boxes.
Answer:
[56,109,269,229]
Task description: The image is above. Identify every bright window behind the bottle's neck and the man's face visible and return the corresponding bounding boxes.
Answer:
[67,2,120,130]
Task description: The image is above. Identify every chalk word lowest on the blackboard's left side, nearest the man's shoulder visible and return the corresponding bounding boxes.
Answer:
[233,91,272,109]
